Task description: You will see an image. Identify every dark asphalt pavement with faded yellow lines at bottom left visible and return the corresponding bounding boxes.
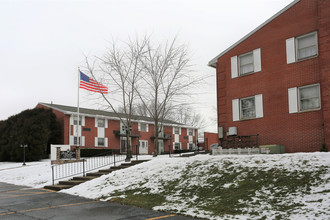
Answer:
[0,182,199,220]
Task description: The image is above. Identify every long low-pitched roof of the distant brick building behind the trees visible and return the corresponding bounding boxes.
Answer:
[39,103,191,127]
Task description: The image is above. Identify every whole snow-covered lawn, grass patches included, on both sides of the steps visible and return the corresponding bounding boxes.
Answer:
[0,153,330,219]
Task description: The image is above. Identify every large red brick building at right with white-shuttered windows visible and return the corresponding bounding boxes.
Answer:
[209,0,330,152]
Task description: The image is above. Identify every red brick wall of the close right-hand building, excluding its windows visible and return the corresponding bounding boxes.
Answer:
[217,0,330,152]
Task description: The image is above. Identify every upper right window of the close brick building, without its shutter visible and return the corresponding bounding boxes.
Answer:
[296,32,317,60]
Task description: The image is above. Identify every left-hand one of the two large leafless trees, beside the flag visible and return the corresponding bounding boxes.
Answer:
[86,38,147,160]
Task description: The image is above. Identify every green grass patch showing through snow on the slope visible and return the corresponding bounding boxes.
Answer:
[102,160,329,219]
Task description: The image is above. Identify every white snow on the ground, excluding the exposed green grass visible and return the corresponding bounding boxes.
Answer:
[0,153,330,219]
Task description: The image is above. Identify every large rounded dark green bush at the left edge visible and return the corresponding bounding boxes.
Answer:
[0,108,61,162]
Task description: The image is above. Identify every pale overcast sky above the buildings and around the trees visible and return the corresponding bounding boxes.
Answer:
[0,0,293,132]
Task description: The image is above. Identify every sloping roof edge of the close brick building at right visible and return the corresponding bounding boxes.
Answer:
[208,0,300,68]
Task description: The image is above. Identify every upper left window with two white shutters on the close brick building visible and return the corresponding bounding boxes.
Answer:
[231,48,261,78]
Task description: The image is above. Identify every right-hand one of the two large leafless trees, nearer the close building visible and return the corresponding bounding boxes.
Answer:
[137,38,201,156]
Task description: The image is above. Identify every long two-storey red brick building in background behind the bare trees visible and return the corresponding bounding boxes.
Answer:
[37,103,198,154]
